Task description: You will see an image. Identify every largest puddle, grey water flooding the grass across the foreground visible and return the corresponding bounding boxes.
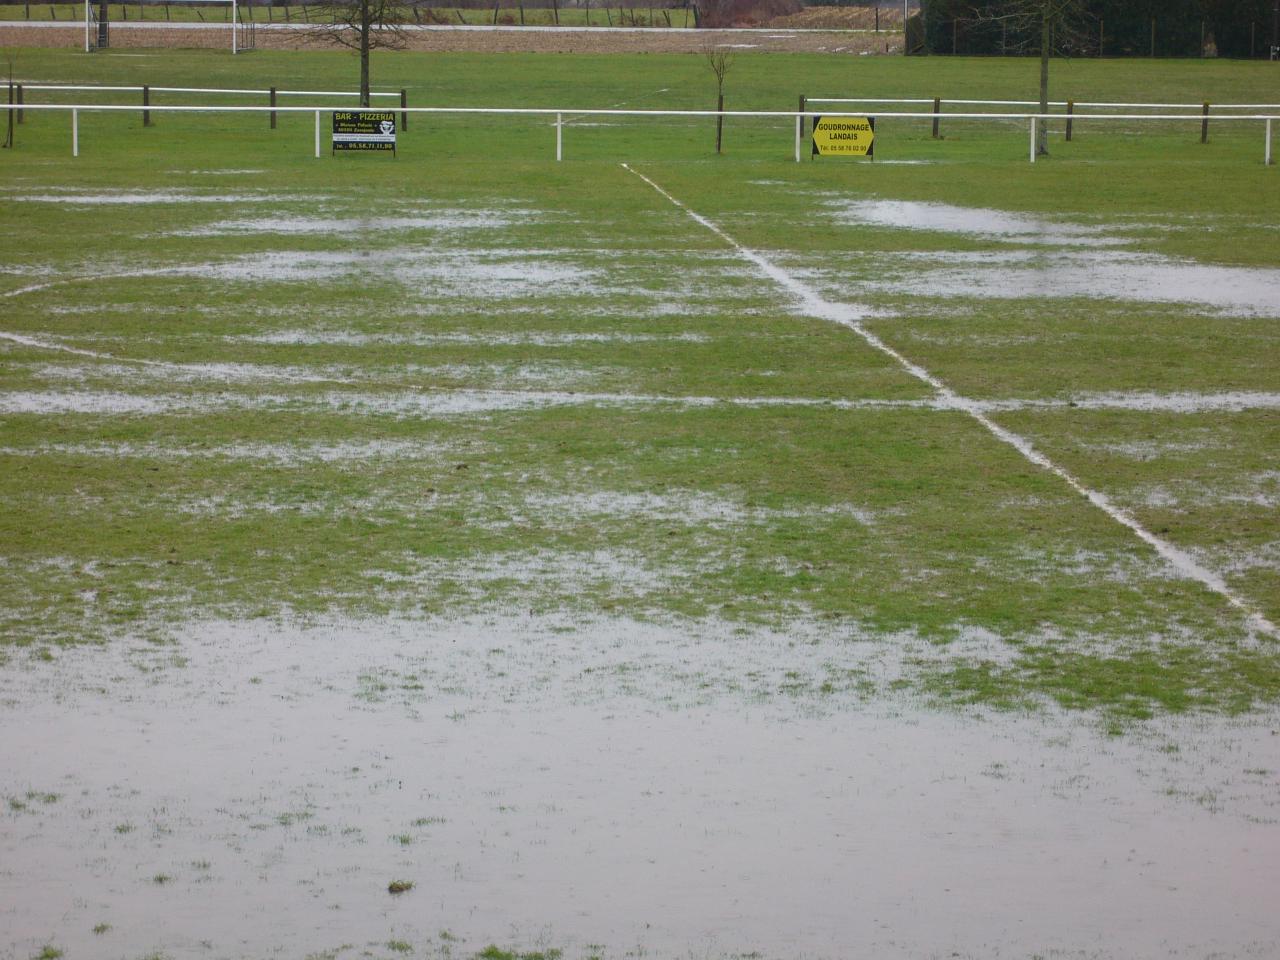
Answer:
[0,617,1280,960]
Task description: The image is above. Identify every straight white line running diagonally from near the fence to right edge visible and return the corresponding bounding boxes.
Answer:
[622,164,1280,639]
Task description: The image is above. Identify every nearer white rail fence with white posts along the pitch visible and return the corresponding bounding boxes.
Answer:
[5,104,1280,165]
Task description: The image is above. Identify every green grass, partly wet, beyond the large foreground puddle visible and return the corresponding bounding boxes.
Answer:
[0,50,1280,717]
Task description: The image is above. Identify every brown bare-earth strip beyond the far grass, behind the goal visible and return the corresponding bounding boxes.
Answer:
[0,23,902,56]
